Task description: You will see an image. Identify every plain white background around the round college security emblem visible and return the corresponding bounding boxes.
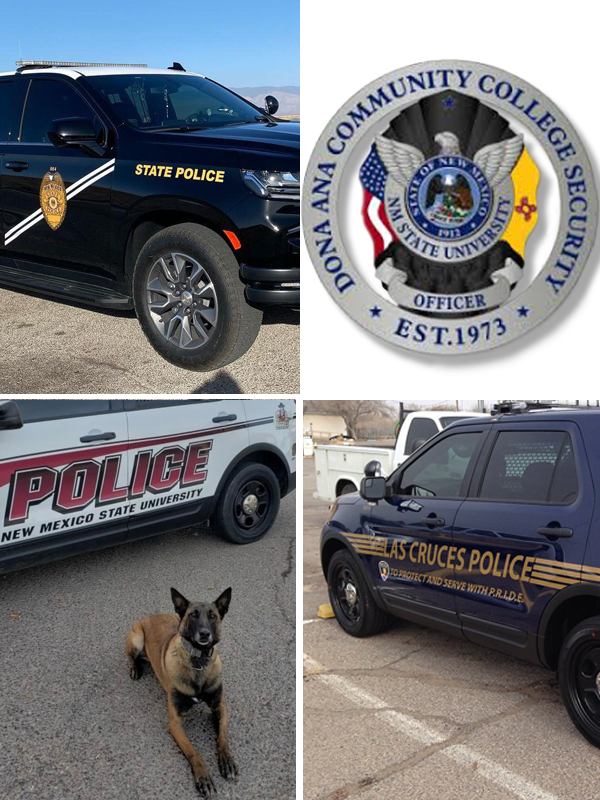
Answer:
[301,0,600,399]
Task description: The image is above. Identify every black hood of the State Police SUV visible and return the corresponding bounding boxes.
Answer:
[154,122,300,170]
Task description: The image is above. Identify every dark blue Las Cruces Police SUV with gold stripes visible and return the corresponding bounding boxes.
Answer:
[321,408,600,746]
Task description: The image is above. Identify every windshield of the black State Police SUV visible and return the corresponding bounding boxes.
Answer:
[87,74,260,130]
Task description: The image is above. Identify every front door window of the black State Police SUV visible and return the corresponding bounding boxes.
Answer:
[19,80,99,142]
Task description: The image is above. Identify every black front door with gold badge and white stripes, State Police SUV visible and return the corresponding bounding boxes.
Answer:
[2,73,115,269]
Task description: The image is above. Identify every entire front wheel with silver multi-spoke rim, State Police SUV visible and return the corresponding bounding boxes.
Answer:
[133,223,262,372]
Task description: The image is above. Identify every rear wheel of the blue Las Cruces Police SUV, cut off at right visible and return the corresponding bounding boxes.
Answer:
[558,617,600,747]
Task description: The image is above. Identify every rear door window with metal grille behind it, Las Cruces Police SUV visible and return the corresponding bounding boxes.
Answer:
[480,431,578,503]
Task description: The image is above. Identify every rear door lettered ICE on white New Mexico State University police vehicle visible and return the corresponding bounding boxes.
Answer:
[125,400,253,528]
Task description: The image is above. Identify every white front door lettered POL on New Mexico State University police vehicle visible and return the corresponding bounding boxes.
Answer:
[0,400,128,547]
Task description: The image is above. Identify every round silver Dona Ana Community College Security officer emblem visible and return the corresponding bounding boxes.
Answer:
[303,61,597,354]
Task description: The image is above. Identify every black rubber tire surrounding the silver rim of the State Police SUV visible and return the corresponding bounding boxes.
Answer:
[133,222,262,372]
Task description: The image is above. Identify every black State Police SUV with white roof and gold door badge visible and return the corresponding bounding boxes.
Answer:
[0,64,300,370]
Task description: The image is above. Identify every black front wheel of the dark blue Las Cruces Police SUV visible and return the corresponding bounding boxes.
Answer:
[327,550,390,639]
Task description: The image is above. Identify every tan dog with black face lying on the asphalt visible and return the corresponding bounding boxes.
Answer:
[125,588,237,797]
